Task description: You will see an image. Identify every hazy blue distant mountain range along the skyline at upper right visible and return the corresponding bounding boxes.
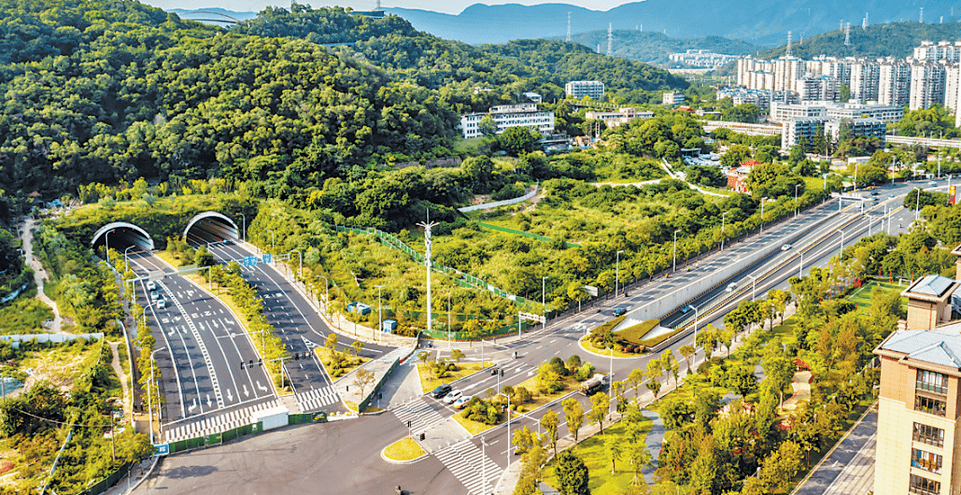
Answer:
[385,0,961,47]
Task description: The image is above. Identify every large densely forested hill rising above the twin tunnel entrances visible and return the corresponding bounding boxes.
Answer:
[0,0,685,202]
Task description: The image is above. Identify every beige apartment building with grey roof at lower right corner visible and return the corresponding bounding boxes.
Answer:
[874,252,961,495]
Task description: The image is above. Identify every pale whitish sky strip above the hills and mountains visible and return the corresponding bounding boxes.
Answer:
[141,0,630,14]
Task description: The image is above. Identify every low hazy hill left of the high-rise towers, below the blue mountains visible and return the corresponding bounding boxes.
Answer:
[554,29,764,65]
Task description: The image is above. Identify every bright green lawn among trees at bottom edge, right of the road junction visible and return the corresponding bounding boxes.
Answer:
[544,418,651,495]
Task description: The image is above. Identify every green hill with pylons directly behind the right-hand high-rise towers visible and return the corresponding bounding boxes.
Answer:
[757,22,961,59]
